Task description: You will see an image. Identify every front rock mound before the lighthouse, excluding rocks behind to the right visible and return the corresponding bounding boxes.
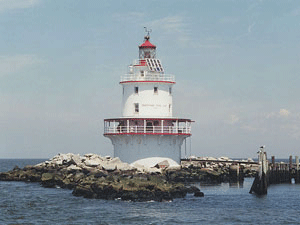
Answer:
[0,153,200,201]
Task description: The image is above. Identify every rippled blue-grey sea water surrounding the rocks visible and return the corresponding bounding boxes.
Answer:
[0,159,300,225]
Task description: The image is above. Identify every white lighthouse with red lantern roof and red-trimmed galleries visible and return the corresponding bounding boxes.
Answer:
[104,32,192,164]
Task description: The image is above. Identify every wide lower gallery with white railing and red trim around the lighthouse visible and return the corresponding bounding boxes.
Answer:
[104,119,192,135]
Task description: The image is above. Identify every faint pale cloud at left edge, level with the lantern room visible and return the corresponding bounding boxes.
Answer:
[0,55,43,77]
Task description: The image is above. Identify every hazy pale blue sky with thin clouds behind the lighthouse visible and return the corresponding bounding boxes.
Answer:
[0,0,300,158]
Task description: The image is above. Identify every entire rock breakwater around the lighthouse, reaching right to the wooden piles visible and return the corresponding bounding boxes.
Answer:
[0,153,257,201]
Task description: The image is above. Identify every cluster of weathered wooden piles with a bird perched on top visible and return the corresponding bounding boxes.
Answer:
[250,146,269,195]
